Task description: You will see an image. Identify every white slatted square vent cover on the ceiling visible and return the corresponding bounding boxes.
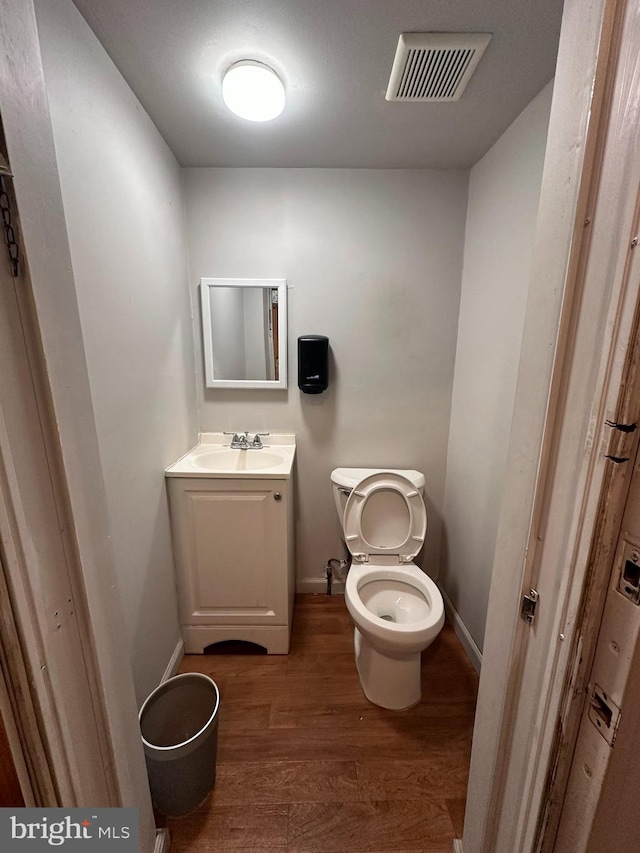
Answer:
[386,33,491,101]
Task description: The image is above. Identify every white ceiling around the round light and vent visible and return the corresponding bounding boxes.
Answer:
[70,0,562,169]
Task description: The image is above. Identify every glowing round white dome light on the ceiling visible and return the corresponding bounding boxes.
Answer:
[222,59,284,121]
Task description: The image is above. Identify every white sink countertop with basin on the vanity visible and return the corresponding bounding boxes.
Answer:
[164,432,296,480]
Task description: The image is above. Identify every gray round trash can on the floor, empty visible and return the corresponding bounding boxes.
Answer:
[139,672,220,817]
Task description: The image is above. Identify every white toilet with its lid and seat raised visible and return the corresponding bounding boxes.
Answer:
[331,468,444,710]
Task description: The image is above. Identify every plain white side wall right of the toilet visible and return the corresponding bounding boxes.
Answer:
[440,83,552,649]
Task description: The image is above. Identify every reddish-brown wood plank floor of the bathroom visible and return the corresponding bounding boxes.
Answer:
[166,595,478,853]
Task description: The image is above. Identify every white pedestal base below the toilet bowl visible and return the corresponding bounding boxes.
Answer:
[353,628,422,711]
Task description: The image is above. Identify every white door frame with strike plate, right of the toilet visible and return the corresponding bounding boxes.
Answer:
[458,0,640,853]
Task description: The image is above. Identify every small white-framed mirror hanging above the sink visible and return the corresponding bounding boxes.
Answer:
[200,278,287,389]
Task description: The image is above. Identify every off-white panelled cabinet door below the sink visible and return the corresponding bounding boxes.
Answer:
[169,478,289,626]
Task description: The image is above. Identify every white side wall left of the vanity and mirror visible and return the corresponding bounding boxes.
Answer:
[37,0,197,700]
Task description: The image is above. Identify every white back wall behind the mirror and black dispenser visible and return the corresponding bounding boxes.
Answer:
[185,169,468,590]
